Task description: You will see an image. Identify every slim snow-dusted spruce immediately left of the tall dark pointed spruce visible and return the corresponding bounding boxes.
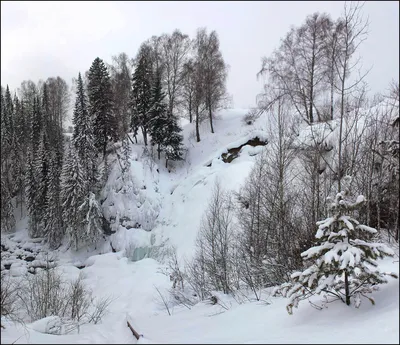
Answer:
[72,73,97,189]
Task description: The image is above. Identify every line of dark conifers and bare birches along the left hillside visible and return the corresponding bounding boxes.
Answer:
[1,28,227,248]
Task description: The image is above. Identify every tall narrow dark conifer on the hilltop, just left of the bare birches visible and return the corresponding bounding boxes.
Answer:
[131,45,153,146]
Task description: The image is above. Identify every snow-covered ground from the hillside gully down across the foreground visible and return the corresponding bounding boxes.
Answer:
[1,109,399,344]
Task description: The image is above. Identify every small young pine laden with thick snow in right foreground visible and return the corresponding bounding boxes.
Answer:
[279,177,397,314]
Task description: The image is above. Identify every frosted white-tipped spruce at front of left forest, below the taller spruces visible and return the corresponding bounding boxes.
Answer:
[61,145,87,249]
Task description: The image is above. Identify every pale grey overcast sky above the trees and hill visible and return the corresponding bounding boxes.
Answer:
[1,1,399,108]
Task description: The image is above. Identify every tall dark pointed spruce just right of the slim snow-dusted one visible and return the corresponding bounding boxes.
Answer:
[87,57,118,157]
